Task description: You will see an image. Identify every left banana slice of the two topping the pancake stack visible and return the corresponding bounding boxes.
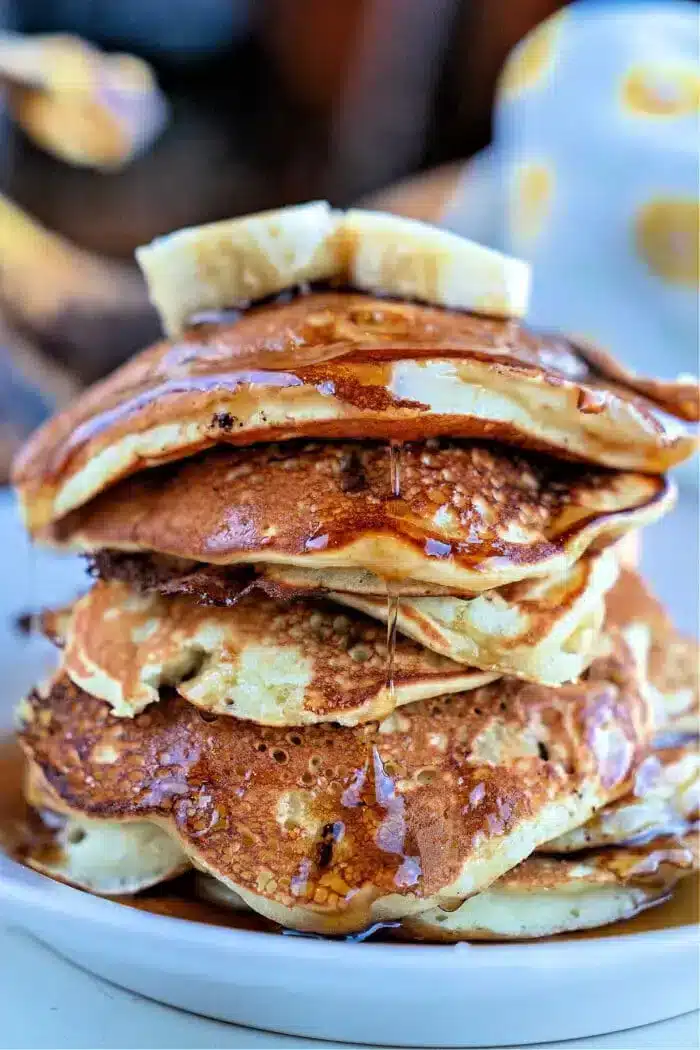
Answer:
[136,201,342,336]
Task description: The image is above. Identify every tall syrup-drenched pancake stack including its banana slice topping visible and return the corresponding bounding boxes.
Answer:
[10,206,699,939]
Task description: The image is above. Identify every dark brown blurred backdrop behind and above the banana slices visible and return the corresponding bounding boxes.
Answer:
[5,0,563,245]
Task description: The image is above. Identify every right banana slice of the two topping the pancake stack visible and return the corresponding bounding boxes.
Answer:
[342,210,530,317]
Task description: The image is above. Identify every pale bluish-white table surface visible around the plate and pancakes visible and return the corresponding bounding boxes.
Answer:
[0,478,700,1050]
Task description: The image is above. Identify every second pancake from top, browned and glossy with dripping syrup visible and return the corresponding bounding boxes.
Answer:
[42,441,674,593]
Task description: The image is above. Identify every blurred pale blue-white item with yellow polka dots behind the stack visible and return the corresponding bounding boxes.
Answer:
[444,2,700,379]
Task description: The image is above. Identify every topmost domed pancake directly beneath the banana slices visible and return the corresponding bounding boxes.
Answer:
[14,292,697,533]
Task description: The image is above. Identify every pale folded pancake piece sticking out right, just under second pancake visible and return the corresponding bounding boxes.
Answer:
[331,549,618,686]
